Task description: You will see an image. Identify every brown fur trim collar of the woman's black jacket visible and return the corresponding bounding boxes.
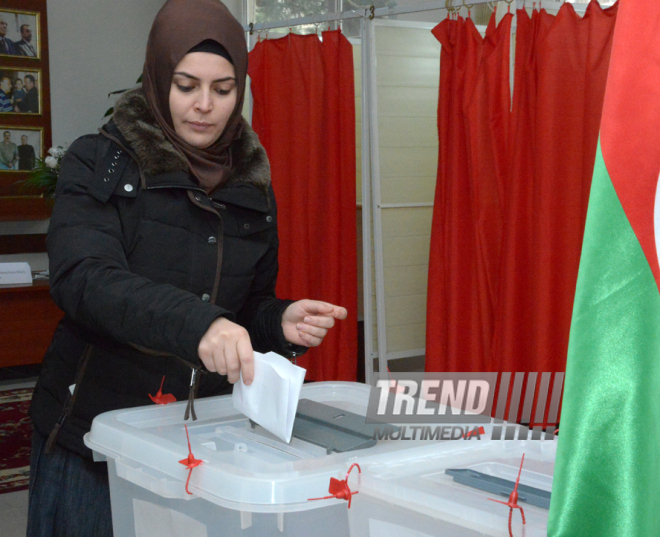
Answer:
[112,88,270,190]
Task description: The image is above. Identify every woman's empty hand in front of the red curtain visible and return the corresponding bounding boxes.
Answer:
[282,299,348,347]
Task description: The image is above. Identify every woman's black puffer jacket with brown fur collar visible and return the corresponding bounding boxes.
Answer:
[30,89,302,456]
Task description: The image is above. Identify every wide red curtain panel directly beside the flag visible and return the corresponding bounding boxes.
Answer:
[492,1,616,382]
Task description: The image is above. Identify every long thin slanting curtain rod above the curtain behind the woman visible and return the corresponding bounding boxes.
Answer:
[243,0,500,32]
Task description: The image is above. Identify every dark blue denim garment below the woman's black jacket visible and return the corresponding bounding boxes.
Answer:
[27,429,112,537]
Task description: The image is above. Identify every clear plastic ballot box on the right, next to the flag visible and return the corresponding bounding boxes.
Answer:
[348,440,557,537]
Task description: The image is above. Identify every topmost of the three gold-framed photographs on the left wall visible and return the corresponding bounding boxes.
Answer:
[0,9,41,60]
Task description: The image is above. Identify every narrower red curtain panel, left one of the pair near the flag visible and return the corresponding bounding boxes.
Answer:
[426,14,512,371]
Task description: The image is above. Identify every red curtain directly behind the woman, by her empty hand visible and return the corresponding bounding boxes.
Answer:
[249,31,357,381]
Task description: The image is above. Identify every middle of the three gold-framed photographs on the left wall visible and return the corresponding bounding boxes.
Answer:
[0,67,43,114]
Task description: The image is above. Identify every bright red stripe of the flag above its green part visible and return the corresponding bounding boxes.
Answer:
[601,0,660,289]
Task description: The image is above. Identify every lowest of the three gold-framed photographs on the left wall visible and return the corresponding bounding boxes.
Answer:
[0,125,44,174]
